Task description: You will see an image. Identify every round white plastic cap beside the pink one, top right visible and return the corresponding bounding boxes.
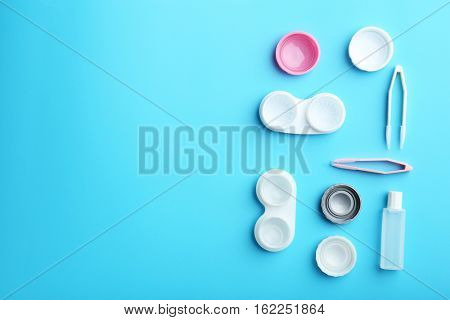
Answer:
[348,27,394,71]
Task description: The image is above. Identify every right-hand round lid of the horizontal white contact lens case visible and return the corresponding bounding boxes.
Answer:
[306,93,345,133]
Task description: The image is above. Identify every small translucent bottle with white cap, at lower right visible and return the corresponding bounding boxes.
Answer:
[380,191,406,270]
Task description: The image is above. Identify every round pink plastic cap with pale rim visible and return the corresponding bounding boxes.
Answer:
[275,31,320,75]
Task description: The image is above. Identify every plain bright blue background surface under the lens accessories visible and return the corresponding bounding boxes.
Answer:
[0,0,450,299]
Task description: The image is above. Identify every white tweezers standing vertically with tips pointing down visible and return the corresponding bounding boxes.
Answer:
[386,65,408,150]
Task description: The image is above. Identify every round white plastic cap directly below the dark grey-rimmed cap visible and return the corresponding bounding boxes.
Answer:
[316,236,357,277]
